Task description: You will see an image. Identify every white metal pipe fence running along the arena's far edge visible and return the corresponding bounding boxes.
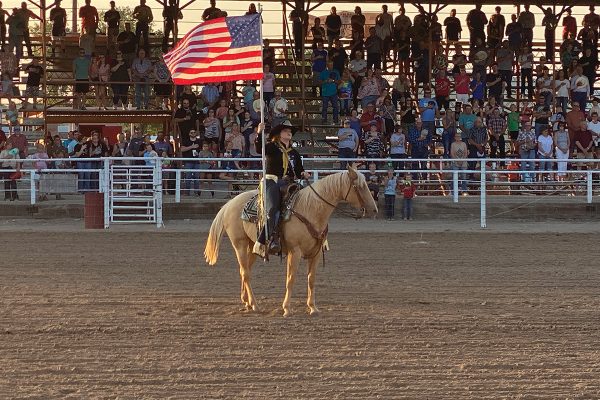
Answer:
[0,157,600,227]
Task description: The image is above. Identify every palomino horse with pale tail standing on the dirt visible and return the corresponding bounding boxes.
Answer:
[204,166,377,316]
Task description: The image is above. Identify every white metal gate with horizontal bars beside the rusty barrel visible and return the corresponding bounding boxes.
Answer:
[104,161,163,228]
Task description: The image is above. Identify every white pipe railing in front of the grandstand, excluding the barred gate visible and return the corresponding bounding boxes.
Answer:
[0,157,600,227]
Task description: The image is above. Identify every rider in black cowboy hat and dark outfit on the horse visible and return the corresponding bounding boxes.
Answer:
[253,120,310,256]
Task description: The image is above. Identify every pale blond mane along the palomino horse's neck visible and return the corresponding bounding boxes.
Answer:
[294,171,354,214]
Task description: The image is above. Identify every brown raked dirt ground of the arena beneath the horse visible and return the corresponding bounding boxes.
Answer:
[0,221,600,400]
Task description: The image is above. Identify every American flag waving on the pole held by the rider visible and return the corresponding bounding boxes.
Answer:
[163,14,263,85]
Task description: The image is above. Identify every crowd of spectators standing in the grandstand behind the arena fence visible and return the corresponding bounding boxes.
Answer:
[0,0,600,200]
